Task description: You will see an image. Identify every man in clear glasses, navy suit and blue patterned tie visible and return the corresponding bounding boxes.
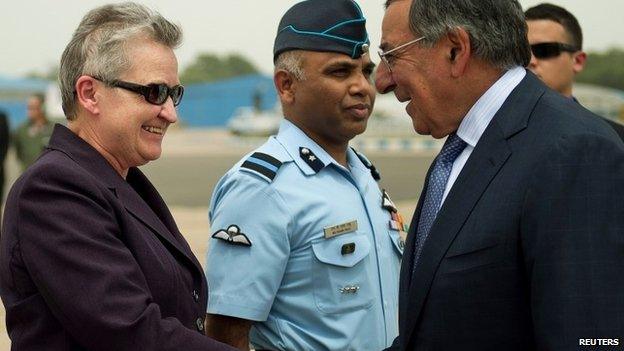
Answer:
[376,0,624,351]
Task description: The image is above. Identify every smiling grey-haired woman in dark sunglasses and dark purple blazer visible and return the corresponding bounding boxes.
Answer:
[0,3,232,351]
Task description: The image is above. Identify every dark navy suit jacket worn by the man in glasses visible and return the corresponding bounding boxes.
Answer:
[393,72,624,351]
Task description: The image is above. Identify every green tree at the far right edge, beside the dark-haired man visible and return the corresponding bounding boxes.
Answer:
[576,48,624,90]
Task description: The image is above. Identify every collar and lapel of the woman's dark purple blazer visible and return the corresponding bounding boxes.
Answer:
[48,124,201,270]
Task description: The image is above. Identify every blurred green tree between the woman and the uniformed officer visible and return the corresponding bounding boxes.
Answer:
[180,53,258,84]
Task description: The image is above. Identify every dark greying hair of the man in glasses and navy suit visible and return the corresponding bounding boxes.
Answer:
[386,0,531,70]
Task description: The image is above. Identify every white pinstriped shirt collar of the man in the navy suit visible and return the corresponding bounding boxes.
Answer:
[457,66,526,148]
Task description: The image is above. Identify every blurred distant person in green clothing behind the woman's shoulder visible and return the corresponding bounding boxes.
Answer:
[12,94,53,170]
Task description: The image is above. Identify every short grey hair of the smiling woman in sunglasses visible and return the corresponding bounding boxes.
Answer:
[59,2,182,120]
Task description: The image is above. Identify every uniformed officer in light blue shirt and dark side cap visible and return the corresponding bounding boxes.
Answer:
[202,0,405,350]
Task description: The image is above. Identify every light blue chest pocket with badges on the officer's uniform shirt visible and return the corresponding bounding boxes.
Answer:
[312,233,375,313]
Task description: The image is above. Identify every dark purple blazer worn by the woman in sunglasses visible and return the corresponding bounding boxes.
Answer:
[0,125,231,351]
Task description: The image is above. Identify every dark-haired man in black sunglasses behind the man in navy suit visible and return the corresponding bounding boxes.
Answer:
[524,4,624,139]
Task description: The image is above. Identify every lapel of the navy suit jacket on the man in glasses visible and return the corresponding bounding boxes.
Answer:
[400,72,545,345]
